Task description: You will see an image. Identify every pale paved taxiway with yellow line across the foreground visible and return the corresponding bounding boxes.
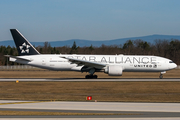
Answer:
[0,100,180,120]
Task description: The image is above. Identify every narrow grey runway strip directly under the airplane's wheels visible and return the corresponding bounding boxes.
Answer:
[0,78,180,82]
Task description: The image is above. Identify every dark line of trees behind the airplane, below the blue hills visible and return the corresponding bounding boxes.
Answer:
[0,39,180,65]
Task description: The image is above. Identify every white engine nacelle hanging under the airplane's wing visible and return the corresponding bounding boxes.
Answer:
[104,65,123,76]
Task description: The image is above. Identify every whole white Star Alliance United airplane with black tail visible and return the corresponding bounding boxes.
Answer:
[5,29,177,79]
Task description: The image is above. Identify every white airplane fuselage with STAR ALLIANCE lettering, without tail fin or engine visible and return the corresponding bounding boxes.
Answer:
[10,54,177,72]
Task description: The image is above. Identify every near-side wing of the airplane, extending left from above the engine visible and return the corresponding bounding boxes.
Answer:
[61,57,106,68]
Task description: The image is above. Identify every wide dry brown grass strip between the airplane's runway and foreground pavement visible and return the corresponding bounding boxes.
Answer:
[0,82,180,102]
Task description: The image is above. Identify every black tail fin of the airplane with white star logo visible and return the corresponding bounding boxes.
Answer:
[10,29,40,55]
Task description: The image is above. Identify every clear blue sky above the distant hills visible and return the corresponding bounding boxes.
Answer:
[0,0,180,42]
